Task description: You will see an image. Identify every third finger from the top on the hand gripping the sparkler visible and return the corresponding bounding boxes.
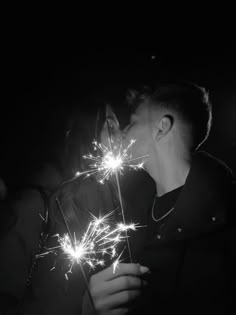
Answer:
[95,290,141,310]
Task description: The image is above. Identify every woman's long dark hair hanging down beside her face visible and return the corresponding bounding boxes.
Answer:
[49,106,120,235]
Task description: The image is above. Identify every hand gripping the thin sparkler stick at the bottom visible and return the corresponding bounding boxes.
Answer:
[83,263,149,315]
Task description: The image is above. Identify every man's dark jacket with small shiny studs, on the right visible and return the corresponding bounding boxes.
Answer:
[125,152,236,314]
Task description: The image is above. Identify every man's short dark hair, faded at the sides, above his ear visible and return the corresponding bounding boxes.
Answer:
[128,82,212,150]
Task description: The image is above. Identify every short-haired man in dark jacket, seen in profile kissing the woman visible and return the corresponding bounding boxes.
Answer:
[84,83,233,315]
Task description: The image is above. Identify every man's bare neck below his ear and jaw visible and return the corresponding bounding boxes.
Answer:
[147,156,191,197]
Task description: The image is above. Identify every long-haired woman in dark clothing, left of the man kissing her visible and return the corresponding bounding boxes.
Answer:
[0,105,121,314]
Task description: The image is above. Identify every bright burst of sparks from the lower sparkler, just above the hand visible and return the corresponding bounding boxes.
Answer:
[38,212,139,273]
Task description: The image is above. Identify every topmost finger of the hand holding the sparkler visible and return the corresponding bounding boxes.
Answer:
[91,263,149,281]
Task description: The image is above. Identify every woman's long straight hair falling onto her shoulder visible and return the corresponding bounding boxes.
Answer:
[46,109,96,232]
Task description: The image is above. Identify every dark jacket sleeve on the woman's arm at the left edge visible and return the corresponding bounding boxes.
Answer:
[0,190,44,314]
